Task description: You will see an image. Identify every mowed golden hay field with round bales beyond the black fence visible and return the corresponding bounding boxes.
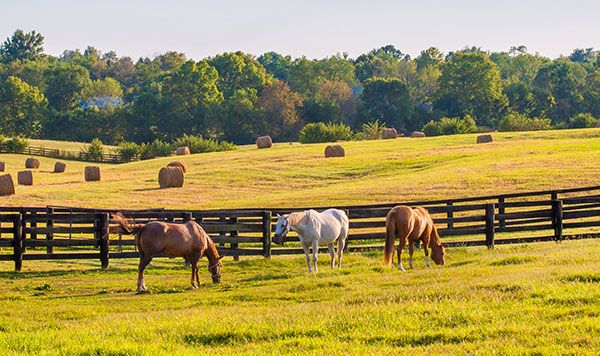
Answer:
[0,129,600,209]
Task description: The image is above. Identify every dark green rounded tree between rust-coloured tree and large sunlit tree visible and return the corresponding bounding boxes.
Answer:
[359,78,414,131]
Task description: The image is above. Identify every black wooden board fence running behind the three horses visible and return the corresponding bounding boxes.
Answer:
[0,186,600,270]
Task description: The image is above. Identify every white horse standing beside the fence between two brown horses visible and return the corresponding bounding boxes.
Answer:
[273,209,349,273]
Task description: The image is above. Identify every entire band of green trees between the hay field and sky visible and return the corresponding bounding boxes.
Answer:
[0,30,600,144]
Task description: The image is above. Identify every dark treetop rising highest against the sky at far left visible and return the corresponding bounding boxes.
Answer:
[0,29,44,63]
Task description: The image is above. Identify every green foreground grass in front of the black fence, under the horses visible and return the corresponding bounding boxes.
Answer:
[0,240,600,355]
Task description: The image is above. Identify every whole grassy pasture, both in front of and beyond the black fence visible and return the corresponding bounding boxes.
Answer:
[0,129,600,355]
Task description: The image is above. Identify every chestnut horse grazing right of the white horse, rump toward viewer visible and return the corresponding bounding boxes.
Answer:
[383,205,445,272]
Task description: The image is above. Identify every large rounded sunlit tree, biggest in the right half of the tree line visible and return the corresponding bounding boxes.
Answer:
[434,51,507,126]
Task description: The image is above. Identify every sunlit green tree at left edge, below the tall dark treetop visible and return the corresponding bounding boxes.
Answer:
[0,76,48,137]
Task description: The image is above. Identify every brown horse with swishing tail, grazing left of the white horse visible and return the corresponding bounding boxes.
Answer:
[110,213,223,293]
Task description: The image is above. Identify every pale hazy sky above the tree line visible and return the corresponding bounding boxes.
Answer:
[0,0,600,60]
